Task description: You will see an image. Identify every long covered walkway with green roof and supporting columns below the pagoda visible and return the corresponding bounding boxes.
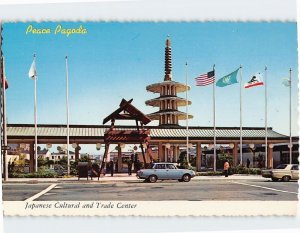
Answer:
[7,124,298,171]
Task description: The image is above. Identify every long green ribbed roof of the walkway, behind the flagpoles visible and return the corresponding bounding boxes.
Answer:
[7,124,299,144]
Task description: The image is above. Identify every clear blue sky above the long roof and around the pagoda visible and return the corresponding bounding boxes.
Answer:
[3,22,298,153]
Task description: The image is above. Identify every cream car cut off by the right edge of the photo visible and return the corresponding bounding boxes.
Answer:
[261,164,299,182]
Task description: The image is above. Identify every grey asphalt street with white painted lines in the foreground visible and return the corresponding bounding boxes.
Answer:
[3,180,298,201]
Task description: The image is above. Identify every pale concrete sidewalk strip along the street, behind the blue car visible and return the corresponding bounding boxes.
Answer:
[2,173,267,183]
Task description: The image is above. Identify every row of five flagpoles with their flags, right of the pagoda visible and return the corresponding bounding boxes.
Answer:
[186,63,292,171]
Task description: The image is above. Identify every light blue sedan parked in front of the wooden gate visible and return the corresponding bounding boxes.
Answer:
[136,163,196,183]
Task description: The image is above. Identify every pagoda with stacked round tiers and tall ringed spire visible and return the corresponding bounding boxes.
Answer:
[145,38,193,126]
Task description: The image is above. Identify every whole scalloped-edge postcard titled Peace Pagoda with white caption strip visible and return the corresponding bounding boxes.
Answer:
[0,0,299,216]
